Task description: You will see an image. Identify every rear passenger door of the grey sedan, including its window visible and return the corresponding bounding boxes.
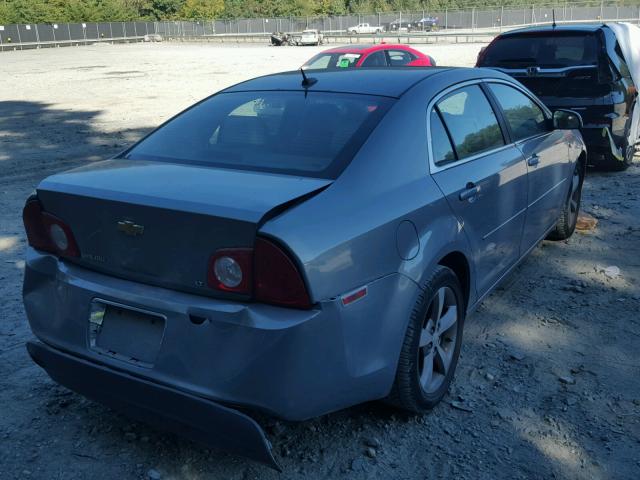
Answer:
[429,83,527,295]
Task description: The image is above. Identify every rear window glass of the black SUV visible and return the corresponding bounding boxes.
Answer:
[479,33,598,68]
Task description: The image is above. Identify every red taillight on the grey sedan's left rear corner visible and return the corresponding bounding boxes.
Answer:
[22,198,80,257]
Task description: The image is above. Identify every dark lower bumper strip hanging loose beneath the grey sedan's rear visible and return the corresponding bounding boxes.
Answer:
[27,342,280,470]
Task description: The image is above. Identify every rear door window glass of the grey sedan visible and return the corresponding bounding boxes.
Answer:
[437,85,504,160]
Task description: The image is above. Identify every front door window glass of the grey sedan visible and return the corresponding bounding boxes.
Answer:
[489,83,548,142]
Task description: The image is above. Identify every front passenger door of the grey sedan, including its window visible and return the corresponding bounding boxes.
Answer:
[488,82,569,249]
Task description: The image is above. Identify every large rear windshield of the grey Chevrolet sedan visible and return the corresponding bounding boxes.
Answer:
[125,91,393,179]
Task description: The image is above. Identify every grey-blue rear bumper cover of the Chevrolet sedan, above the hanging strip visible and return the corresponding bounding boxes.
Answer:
[23,248,420,421]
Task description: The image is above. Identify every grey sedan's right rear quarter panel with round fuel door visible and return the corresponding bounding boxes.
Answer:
[261,70,480,303]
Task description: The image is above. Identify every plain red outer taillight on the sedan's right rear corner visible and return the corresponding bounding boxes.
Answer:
[253,238,311,308]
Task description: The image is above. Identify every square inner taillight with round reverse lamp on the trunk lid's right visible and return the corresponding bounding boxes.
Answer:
[208,248,253,294]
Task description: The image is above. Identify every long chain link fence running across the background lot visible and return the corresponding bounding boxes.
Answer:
[0,3,640,51]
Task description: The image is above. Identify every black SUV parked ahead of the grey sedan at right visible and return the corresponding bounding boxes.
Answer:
[476,24,637,170]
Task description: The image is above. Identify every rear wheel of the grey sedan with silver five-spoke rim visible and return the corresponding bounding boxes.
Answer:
[386,266,466,413]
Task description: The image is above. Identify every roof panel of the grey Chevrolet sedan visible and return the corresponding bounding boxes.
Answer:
[224,67,455,98]
